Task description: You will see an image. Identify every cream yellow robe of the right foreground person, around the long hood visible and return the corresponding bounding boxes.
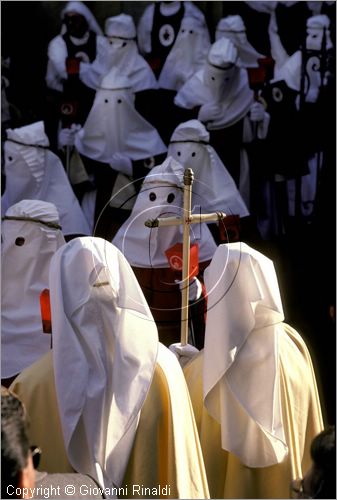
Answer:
[184,324,323,498]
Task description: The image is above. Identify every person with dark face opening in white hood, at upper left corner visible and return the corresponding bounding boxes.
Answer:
[45,1,108,146]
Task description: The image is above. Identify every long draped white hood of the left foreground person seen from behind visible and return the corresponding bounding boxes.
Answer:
[49,237,158,488]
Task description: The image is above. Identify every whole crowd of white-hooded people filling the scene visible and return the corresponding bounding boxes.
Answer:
[1,1,335,498]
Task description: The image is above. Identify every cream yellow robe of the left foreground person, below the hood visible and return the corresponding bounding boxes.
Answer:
[10,352,209,498]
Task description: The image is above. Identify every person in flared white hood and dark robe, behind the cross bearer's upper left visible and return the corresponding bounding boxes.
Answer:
[75,69,167,239]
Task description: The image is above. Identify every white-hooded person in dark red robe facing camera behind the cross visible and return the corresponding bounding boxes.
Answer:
[112,157,216,345]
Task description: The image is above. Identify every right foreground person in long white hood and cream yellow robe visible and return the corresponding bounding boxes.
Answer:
[184,243,323,498]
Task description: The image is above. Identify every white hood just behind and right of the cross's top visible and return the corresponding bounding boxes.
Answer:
[167,120,249,217]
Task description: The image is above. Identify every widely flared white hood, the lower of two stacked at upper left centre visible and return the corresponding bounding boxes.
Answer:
[75,70,167,164]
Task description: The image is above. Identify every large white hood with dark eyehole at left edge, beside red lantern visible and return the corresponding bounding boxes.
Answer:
[1,200,65,378]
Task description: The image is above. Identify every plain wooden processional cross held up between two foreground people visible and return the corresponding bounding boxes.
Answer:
[145,168,226,345]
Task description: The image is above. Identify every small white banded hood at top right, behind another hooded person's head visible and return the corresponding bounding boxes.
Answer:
[215,15,264,68]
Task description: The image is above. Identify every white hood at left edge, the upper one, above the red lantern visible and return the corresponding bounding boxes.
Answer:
[1,121,90,235]
